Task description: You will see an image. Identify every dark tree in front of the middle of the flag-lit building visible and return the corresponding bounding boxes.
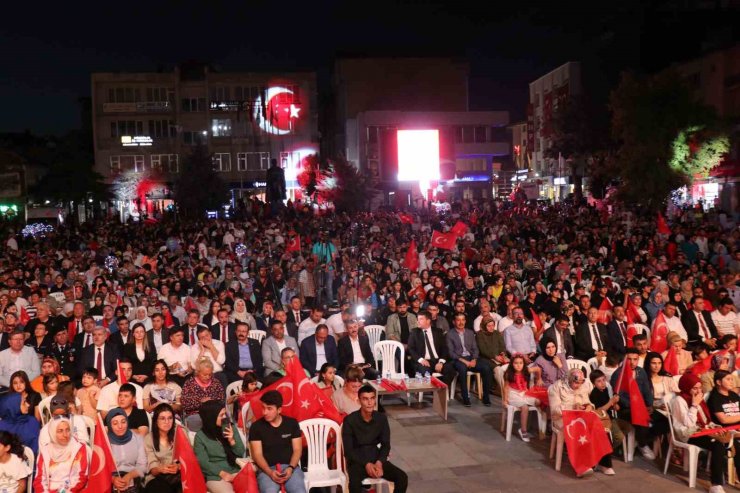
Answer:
[174,146,229,219]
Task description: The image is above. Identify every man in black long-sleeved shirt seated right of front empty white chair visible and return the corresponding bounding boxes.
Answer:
[342,385,409,493]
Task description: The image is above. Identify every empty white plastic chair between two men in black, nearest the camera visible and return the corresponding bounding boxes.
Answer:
[298,418,346,491]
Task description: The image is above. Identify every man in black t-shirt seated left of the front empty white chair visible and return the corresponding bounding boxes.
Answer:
[249,390,306,493]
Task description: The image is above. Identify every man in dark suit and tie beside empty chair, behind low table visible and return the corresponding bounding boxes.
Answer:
[408,310,457,387]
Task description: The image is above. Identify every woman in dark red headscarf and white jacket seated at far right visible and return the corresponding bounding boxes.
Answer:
[670,373,740,493]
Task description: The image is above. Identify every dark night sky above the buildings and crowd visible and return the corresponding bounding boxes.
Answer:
[0,0,740,134]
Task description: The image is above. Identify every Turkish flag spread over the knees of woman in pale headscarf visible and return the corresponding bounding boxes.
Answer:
[563,411,612,474]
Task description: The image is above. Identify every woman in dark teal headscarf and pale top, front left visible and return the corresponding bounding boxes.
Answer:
[105,407,146,493]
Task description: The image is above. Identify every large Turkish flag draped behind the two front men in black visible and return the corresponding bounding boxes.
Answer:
[250,358,342,423]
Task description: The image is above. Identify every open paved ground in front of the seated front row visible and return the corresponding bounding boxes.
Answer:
[384,392,712,493]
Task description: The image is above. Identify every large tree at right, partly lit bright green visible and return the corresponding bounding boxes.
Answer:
[610,72,728,210]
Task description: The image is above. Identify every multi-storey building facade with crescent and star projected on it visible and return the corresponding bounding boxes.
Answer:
[92,65,319,217]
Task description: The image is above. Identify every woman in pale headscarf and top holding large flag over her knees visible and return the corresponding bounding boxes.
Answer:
[547,368,615,477]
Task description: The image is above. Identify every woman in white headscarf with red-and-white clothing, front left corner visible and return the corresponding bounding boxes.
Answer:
[33,416,88,493]
